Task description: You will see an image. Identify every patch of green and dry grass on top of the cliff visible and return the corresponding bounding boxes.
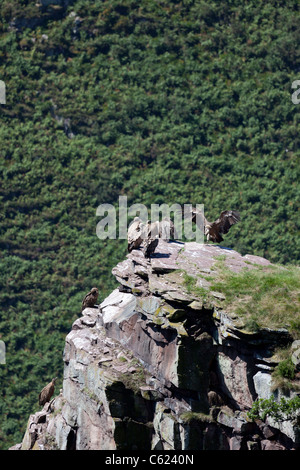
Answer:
[210,262,300,338]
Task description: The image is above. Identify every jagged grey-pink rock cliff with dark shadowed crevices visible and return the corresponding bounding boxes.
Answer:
[16,240,299,450]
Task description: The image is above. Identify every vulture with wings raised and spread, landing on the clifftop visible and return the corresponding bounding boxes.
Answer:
[188,208,240,243]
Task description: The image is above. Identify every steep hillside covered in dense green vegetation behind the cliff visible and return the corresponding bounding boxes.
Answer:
[0,0,300,448]
